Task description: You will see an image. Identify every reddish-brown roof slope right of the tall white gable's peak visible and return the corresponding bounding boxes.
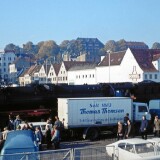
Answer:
[130,49,157,72]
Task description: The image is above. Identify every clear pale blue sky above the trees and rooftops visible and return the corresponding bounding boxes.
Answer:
[0,0,160,49]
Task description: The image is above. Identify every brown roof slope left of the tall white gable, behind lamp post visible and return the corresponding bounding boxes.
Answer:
[98,51,126,66]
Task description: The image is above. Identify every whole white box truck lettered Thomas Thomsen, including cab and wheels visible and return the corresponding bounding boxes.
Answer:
[58,97,150,139]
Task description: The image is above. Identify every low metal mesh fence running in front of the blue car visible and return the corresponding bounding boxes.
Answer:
[0,146,113,160]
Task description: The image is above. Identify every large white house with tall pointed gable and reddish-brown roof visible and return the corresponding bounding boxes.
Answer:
[96,48,158,83]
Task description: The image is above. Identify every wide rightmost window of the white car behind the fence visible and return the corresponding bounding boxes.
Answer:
[135,143,154,154]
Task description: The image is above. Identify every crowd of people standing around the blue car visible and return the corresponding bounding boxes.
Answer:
[0,115,64,150]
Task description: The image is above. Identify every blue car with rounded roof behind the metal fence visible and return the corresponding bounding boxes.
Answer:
[1,130,39,160]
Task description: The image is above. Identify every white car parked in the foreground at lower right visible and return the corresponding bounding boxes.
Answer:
[106,138,160,160]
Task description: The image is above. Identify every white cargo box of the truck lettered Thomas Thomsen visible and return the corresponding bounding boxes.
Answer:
[58,97,132,128]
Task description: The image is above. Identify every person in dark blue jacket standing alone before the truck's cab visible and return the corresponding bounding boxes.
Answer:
[140,116,148,139]
